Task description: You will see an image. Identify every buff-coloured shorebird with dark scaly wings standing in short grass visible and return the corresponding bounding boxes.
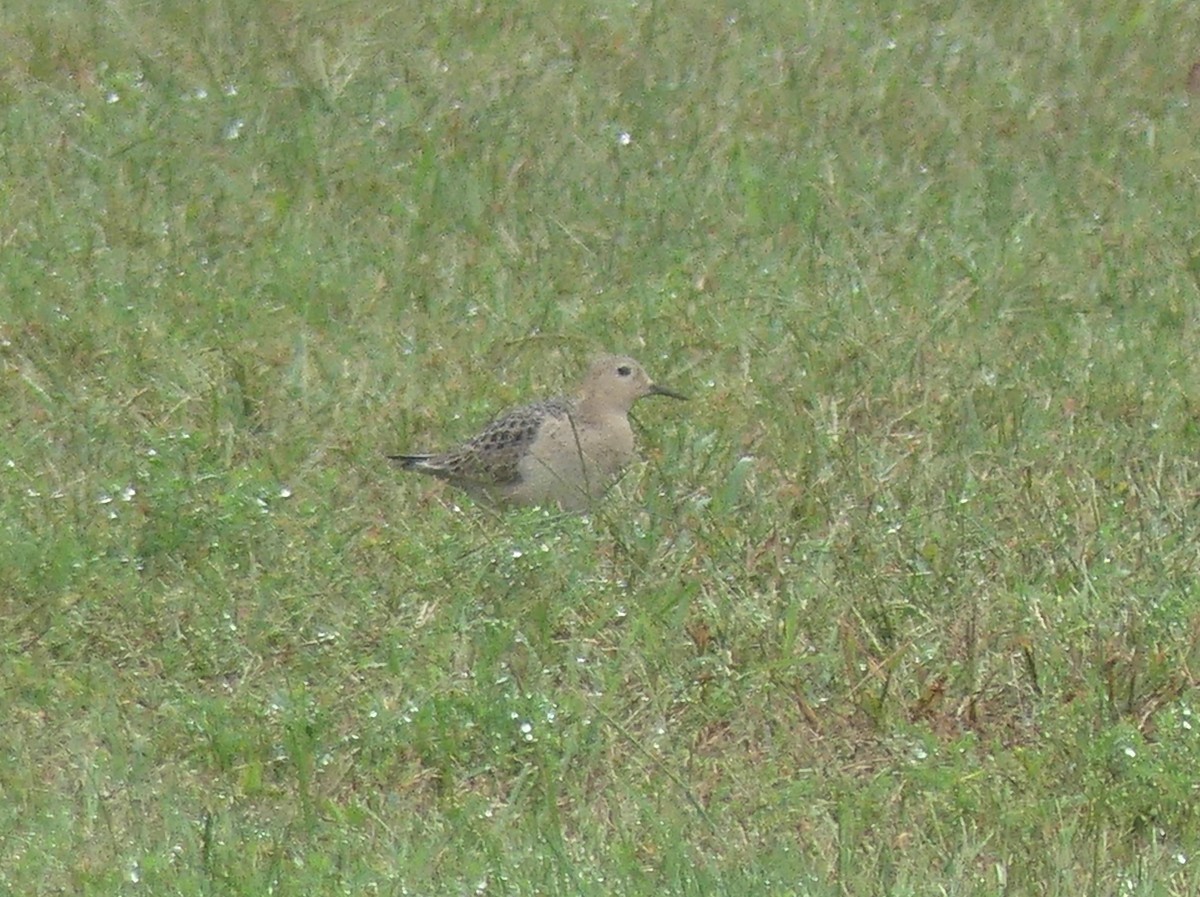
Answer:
[388,355,686,512]
